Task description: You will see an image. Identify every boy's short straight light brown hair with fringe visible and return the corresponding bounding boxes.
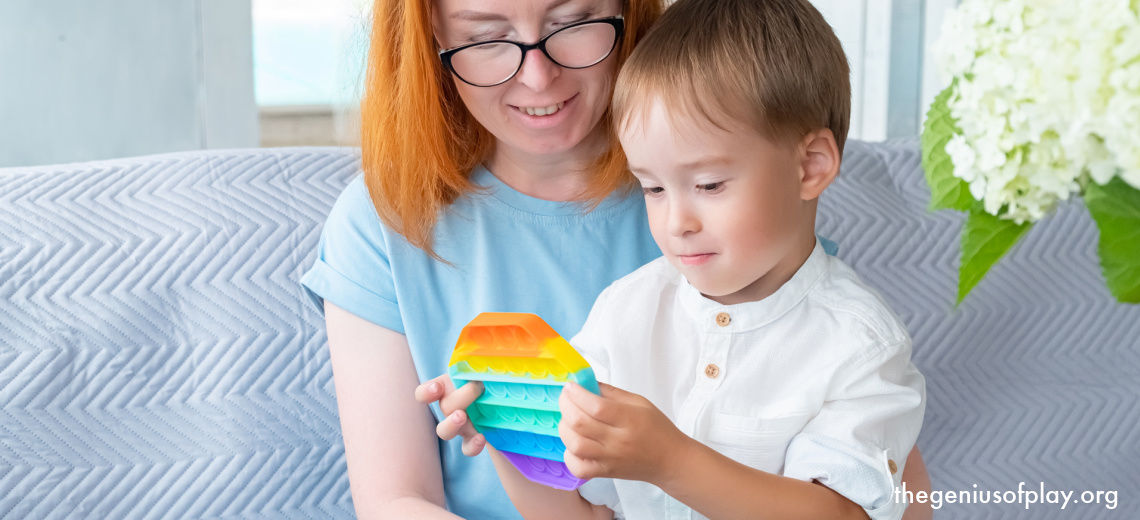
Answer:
[613,0,850,154]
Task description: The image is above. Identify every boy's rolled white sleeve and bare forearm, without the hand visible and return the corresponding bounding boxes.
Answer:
[659,338,926,520]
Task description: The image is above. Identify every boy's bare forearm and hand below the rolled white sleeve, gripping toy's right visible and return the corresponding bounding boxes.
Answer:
[559,384,868,520]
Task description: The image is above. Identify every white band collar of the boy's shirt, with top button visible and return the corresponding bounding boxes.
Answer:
[677,239,829,333]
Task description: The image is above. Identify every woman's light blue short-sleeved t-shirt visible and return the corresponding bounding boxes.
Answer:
[301,166,833,520]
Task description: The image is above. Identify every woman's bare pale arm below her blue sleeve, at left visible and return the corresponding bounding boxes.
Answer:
[325,301,459,520]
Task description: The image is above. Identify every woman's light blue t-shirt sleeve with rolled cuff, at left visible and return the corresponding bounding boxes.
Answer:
[301,176,404,333]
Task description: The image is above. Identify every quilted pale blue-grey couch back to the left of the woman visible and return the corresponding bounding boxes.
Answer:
[0,148,359,519]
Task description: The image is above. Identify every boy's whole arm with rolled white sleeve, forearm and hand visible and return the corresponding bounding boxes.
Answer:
[559,340,926,520]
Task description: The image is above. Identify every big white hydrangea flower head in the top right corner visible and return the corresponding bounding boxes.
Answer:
[935,0,1140,224]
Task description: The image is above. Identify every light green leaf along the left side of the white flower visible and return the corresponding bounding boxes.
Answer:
[922,80,975,211]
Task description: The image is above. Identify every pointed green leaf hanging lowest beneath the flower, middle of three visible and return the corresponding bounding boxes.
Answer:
[958,208,1033,304]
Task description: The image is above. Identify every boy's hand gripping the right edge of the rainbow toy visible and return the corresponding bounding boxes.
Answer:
[559,383,692,484]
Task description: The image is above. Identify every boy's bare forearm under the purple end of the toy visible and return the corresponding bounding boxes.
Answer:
[487,445,613,520]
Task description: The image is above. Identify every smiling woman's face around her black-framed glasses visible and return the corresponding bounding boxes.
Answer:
[432,0,621,160]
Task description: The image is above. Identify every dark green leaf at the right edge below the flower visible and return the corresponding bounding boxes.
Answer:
[1084,177,1140,303]
